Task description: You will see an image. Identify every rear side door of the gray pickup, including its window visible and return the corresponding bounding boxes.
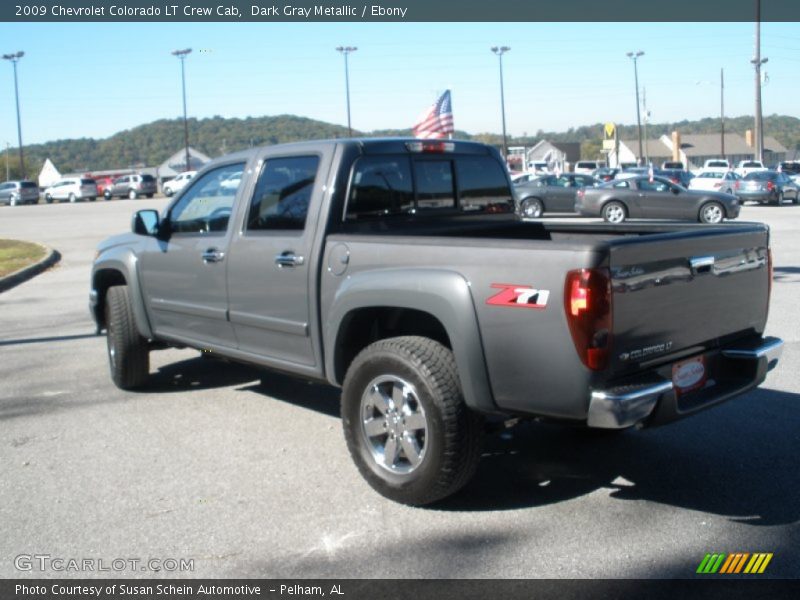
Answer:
[228,148,332,372]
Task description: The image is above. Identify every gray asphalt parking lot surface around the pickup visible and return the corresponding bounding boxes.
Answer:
[0,199,800,578]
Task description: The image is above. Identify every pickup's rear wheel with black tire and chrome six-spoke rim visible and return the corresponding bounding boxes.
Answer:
[342,336,483,505]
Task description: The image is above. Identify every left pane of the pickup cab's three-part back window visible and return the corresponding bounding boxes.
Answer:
[347,156,414,218]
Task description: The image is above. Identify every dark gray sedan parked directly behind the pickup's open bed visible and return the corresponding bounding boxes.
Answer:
[575,177,740,223]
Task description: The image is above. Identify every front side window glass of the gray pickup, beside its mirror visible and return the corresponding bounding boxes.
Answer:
[169,163,244,233]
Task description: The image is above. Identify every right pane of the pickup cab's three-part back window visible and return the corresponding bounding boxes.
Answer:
[456,156,514,212]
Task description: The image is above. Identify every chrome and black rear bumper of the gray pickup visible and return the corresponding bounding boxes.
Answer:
[587,338,783,429]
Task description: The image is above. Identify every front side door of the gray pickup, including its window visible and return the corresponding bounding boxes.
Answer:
[139,161,245,348]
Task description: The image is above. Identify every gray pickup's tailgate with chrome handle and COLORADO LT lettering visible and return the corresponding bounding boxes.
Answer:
[608,224,770,374]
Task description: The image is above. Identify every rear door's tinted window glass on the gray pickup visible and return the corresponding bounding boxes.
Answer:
[247,156,319,231]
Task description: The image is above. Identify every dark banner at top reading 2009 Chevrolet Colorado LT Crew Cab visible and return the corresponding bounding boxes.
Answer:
[0,0,800,22]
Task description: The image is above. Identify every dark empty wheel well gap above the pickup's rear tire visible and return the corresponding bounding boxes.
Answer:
[334,306,452,383]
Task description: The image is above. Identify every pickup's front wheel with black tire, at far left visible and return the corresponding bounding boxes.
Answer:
[106,285,150,390]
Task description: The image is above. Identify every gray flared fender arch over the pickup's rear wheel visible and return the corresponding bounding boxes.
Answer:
[324,268,498,412]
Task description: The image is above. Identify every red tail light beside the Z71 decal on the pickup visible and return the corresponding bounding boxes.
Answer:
[564,269,612,371]
